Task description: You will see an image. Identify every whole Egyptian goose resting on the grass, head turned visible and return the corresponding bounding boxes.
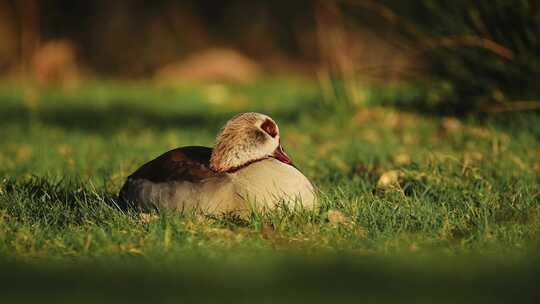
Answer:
[119,113,316,215]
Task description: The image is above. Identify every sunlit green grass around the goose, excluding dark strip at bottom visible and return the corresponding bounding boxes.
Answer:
[0,81,540,302]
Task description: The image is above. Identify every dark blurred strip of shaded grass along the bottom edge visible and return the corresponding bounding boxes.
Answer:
[0,253,539,303]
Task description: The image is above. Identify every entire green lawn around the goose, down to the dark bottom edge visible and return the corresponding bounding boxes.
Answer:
[0,80,540,302]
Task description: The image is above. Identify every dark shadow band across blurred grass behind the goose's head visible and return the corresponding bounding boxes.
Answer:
[0,100,315,134]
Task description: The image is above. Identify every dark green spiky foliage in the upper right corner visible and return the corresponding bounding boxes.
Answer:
[340,0,540,114]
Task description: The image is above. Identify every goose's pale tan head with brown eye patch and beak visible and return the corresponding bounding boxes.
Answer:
[210,113,292,173]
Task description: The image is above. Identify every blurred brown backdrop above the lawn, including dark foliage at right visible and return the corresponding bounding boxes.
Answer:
[0,0,540,114]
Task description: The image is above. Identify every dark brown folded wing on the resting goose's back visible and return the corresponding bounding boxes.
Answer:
[129,146,216,183]
